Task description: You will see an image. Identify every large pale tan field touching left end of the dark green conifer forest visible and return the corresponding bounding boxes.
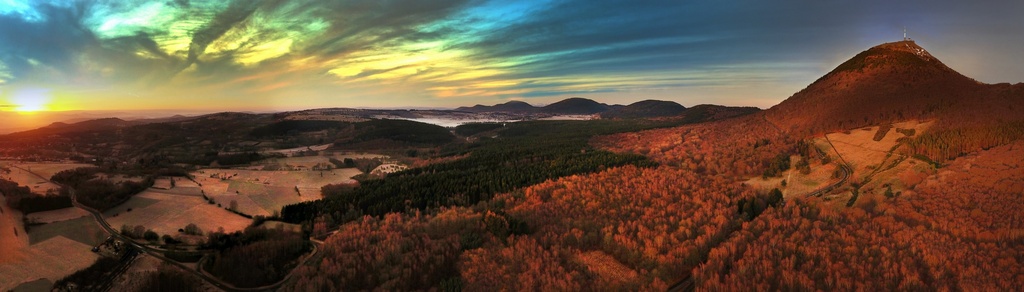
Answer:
[190,168,361,215]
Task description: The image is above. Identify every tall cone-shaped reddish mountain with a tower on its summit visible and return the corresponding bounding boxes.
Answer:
[766,41,1024,133]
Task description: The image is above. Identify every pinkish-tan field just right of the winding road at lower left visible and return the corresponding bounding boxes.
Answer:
[104,189,251,236]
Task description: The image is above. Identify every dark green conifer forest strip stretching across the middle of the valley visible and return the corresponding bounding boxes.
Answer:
[282,121,668,223]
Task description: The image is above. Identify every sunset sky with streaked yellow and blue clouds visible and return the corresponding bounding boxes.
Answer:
[0,0,1024,113]
